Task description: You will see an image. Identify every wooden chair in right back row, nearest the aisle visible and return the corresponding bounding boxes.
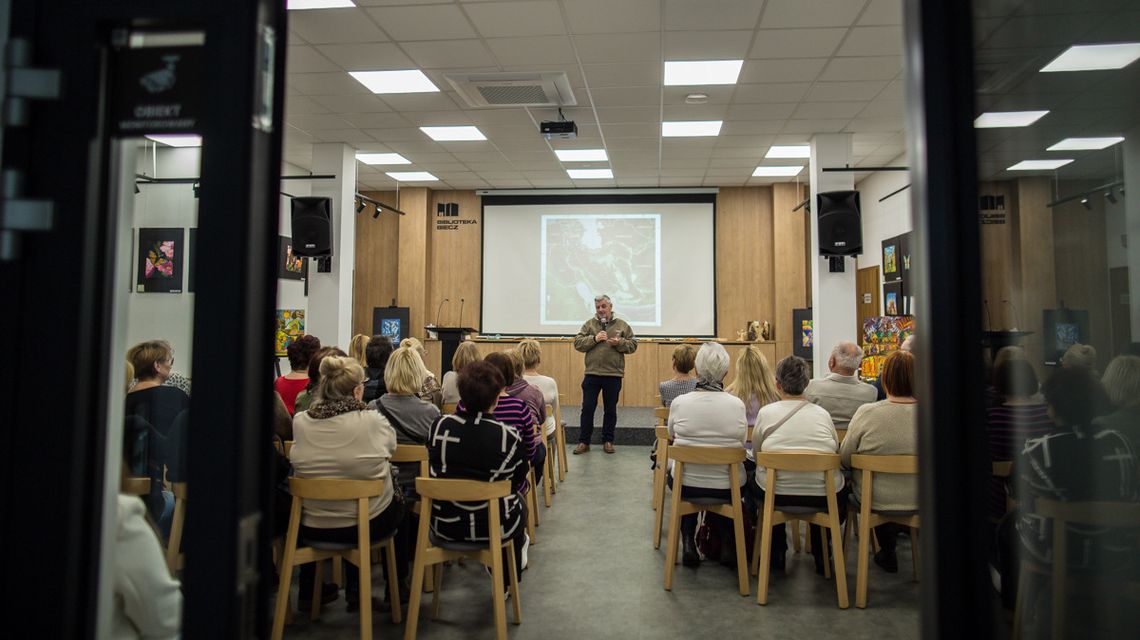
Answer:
[658,445,750,596]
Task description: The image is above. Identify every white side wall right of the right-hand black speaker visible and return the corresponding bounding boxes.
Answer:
[855,154,914,314]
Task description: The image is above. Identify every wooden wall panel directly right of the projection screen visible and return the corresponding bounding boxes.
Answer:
[716,187,774,340]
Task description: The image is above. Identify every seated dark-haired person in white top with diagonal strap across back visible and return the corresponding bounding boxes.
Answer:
[752,356,847,575]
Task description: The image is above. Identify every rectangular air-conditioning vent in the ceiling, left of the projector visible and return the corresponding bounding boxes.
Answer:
[445,71,578,108]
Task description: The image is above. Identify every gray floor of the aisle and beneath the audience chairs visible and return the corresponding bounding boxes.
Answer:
[285,446,919,640]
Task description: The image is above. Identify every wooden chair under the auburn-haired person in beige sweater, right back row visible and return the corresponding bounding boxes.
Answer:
[844,454,919,609]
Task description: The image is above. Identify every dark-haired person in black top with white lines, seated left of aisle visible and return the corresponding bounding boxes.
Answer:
[428,360,530,590]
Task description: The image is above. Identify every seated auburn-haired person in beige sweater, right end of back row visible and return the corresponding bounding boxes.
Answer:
[839,351,919,574]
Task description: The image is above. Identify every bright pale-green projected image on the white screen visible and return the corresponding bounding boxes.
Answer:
[539,213,661,326]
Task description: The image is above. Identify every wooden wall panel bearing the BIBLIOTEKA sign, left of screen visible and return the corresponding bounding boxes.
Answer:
[428,191,482,329]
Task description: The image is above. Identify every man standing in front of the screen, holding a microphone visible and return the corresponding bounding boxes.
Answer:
[573,295,637,455]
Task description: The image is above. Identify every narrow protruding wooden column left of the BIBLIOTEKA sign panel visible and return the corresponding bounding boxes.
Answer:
[389,187,435,339]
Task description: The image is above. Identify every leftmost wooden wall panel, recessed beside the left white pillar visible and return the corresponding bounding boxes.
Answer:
[352,192,400,335]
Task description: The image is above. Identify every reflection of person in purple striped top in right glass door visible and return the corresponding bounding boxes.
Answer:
[986,358,1053,520]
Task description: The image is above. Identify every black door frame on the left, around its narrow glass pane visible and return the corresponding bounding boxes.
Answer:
[0,0,288,638]
